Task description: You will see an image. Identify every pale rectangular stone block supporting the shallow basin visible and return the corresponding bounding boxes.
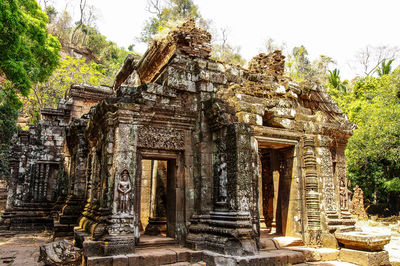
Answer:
[339,248,390,266]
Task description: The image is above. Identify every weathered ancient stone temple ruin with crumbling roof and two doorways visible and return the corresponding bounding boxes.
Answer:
[2,21,384,265]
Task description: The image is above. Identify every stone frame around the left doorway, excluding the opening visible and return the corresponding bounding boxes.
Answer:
[134,149,186,243]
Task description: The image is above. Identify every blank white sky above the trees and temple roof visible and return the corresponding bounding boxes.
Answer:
[54,0,400,78]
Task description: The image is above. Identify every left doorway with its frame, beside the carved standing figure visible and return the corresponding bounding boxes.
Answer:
[136,153,184,245]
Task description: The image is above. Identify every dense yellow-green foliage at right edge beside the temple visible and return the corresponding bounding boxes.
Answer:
[333,69,400,210]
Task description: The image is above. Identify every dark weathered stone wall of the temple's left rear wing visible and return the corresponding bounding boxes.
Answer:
[2,84,112,229]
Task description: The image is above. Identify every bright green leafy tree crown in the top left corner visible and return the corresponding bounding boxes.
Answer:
[0,0,60,95]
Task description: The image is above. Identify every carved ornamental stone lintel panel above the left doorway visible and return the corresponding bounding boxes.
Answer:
[137,126,185,150]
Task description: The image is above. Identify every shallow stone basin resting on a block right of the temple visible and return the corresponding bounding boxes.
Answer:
[335,232,390,251]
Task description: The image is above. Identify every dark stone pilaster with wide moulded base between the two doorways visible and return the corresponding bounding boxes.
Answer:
[187,124,258,256]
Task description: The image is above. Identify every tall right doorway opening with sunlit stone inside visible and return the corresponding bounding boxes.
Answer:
[258,143,294,236]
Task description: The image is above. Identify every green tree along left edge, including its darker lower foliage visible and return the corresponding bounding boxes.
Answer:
[0,0,61,181]
